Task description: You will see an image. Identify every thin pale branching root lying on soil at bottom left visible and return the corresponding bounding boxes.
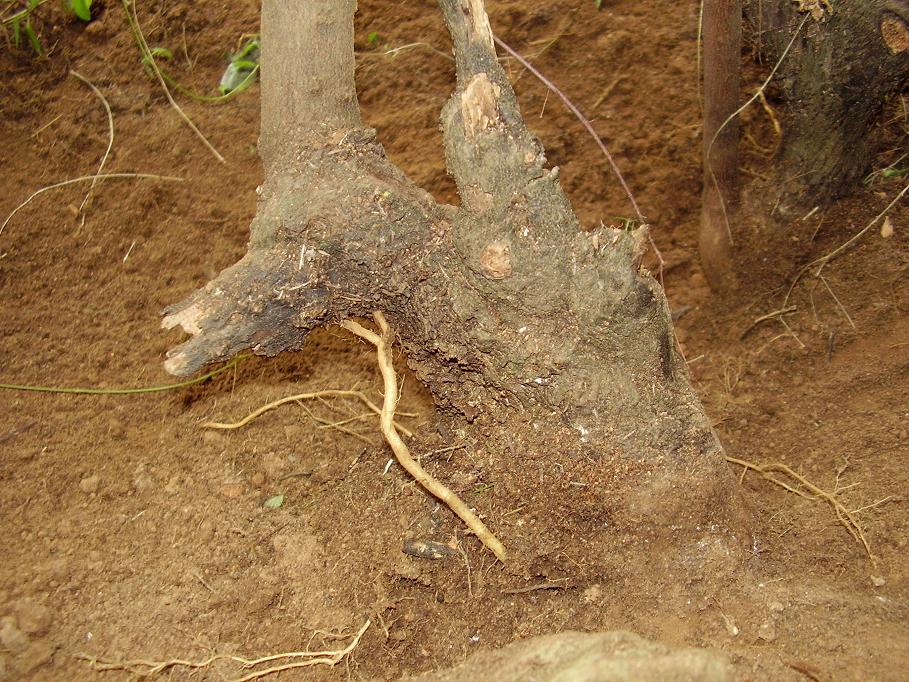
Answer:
[76,620,372,682]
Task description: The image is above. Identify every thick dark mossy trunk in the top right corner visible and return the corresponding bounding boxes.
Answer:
[745,0,909,215]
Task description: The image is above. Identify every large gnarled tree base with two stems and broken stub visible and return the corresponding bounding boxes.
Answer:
[163,0,744,572]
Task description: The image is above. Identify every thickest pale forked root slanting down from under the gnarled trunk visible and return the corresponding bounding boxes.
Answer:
[341,312,505,562]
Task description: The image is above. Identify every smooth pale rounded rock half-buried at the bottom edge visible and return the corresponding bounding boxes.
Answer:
[406,631,737,682]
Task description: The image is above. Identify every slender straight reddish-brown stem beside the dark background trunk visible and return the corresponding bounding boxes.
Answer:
[698,0,742,291]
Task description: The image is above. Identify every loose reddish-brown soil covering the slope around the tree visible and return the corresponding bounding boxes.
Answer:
[0,0,909,680]
